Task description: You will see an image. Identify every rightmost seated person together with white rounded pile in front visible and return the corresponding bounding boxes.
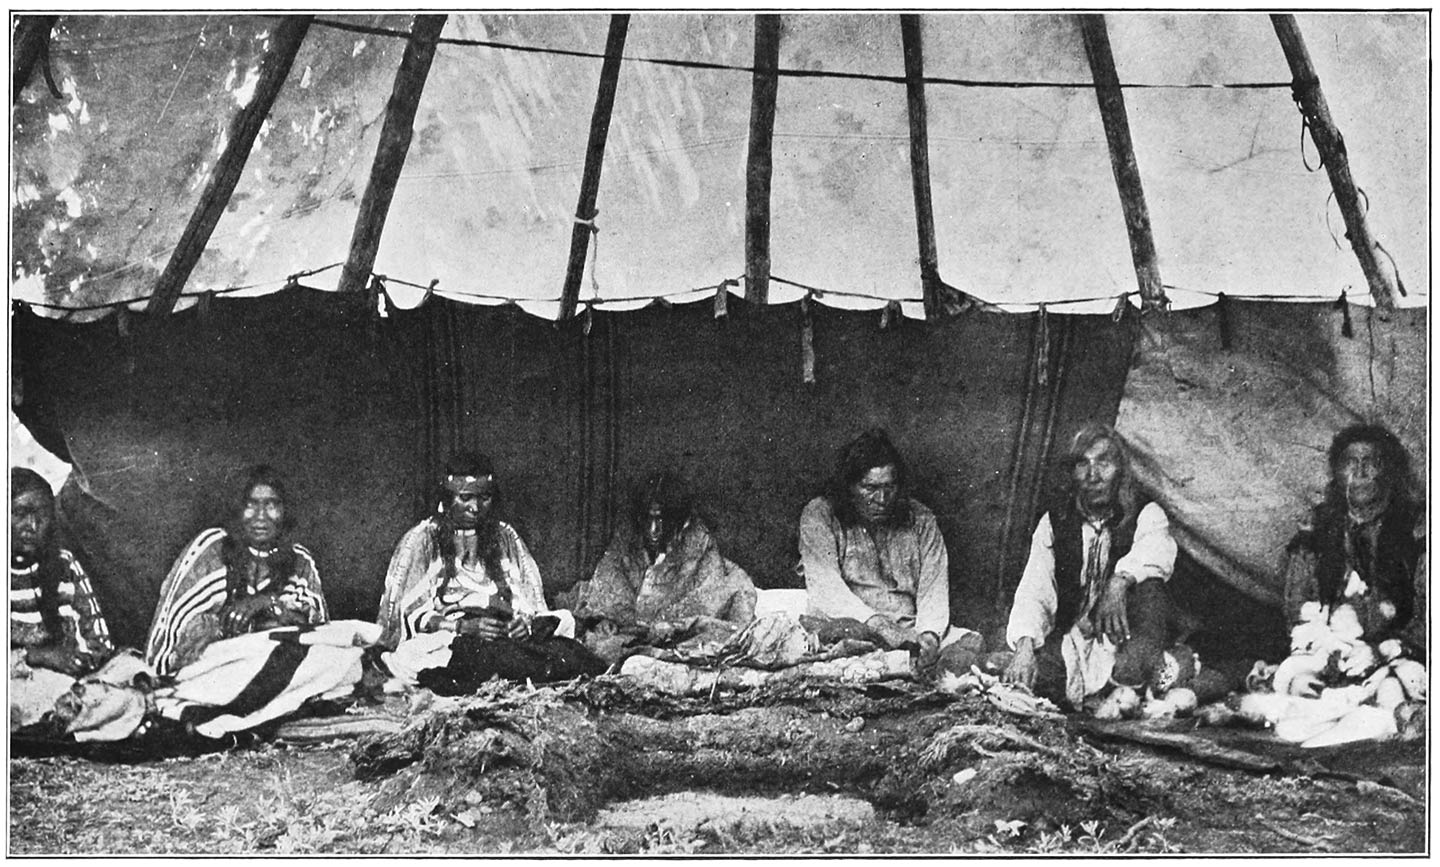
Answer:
[1240,423,1427,746]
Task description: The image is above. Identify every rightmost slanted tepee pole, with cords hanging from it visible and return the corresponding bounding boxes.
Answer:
[1270,14,1395,310]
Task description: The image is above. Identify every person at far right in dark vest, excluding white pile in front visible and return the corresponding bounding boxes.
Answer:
[1284,425,1426,650]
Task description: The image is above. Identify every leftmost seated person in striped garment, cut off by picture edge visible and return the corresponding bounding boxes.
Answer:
[10,467,115,730]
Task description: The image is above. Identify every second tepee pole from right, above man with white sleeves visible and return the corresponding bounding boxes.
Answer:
[1079,14,1166,310]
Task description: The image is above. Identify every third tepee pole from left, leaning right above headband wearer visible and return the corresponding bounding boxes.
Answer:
[338,14,446,292]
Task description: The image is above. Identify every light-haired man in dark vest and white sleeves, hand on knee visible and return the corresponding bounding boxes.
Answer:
[1002,423,1182,709]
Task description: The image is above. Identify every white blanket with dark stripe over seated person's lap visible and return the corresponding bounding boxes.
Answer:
[154,621,380,737]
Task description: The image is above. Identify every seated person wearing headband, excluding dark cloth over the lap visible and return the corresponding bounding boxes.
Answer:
[380,452,587,684]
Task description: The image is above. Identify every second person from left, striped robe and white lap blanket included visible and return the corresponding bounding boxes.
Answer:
[145,465,379,737]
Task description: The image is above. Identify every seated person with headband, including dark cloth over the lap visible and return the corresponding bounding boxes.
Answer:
[380,451,605,694]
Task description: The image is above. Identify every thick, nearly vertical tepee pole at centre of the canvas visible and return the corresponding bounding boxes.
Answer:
[744,14,780,304]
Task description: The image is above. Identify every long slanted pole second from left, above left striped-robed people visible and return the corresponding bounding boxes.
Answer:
[145,14,314,315]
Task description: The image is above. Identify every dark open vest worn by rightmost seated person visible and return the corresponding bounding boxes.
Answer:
[1297,503,1424,629]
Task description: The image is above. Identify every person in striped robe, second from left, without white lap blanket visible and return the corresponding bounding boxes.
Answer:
[145,465,330,675]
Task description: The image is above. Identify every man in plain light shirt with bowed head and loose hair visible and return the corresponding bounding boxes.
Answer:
[799,431,984,673]
